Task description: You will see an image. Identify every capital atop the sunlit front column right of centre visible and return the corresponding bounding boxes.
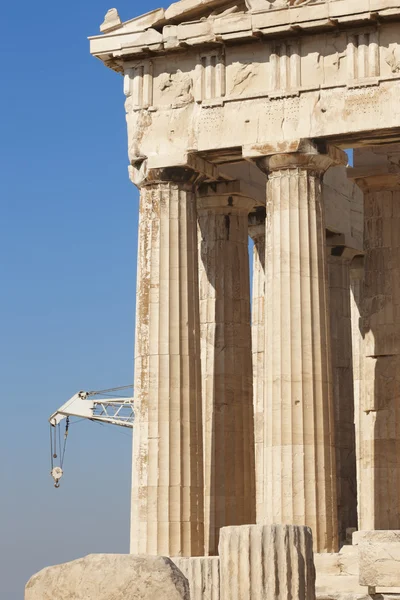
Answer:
[254,140,348,175]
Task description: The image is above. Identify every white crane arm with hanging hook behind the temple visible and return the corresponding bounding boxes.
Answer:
[49,385,135,488]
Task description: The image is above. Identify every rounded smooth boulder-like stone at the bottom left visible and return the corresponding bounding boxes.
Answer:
[25,554,190,600]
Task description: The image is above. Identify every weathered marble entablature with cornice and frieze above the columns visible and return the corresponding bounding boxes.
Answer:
[91,0,400,167]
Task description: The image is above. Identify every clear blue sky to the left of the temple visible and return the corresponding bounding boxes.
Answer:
[0,0,162,600]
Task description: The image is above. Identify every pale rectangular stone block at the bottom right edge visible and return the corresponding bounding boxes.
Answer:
[354,531,400,588]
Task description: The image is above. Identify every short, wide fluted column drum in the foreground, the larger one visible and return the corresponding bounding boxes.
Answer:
[219,525,315,600]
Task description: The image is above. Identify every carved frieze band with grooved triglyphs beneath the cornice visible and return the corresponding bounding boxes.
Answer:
[124,20,400,112]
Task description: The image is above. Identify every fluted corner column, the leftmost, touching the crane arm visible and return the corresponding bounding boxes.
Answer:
[131,168,204,556]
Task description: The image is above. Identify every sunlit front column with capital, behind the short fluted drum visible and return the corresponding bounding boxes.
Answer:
[259,144,343,552]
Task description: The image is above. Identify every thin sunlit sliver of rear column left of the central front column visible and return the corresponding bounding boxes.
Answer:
[249,208,265,514]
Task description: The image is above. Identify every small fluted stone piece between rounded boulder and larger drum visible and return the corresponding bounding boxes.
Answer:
[171,556,220,600]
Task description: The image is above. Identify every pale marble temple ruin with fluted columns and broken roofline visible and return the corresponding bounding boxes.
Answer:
[26,0,400,600]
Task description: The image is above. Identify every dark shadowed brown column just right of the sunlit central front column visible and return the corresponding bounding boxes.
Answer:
[327,243,357,545]
